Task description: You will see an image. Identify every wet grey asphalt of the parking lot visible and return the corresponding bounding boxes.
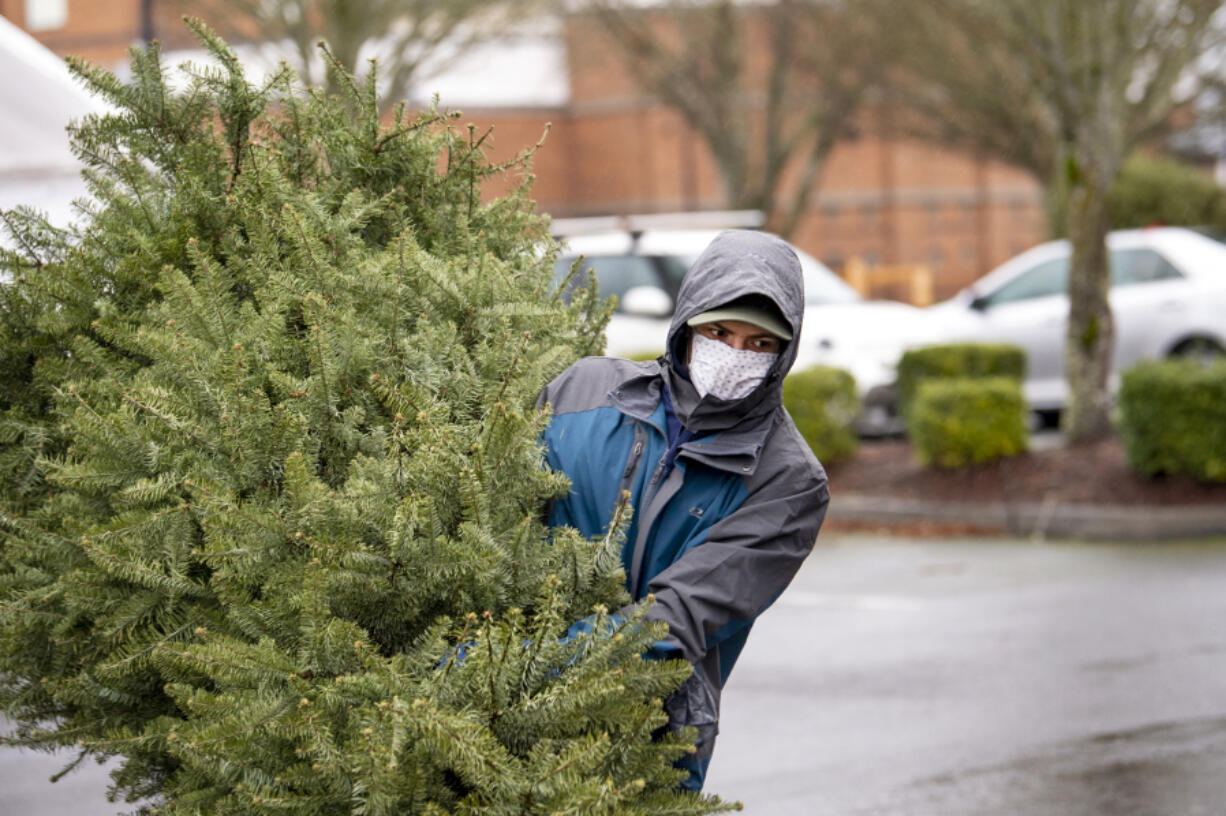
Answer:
[0,534,1226,816]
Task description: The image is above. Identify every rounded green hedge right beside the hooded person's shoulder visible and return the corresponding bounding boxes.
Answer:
[783,365,859,464]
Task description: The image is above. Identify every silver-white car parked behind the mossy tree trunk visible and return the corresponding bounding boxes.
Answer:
[924,227,1226,412]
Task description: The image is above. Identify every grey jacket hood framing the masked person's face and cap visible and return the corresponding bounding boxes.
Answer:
[664,229,804,431]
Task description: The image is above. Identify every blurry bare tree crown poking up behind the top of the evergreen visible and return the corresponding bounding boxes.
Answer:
[170,0,546,107]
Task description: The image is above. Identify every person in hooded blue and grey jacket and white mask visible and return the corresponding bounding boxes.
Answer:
[539,230,830,790]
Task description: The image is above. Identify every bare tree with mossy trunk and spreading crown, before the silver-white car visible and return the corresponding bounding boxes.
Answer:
[897,0,1224,441]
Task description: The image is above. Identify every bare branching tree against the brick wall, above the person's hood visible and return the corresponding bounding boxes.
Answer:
[573,0,883,235]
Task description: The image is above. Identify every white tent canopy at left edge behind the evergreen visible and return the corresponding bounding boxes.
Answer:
[0,17,104,224]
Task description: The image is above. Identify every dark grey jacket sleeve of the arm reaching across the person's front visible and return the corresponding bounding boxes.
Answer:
[647,451,830,663]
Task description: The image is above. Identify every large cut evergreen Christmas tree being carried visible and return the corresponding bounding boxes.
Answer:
[0,23,728,815]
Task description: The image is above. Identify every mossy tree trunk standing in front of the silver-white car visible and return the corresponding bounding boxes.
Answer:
[1063,171,1114,444]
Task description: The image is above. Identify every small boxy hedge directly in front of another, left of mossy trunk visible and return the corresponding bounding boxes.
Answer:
[907,377,1029,468]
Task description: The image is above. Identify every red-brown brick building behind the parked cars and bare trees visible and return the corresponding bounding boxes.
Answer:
[0,0,1046,298]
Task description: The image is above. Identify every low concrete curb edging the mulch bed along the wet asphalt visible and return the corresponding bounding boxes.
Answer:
[828,494,1226,540]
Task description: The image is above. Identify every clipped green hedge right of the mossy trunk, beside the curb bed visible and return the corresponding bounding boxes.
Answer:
[1119,360,1226,482]
